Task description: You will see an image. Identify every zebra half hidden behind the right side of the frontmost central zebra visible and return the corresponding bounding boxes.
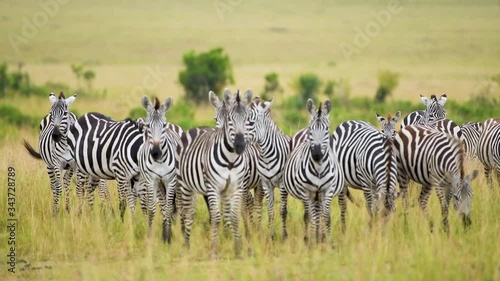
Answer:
[251,97,290,239]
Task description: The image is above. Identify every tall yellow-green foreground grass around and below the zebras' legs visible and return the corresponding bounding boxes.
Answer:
[0,140,500,280]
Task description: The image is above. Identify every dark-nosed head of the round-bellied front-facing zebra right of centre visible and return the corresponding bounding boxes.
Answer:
[307,99,332,162]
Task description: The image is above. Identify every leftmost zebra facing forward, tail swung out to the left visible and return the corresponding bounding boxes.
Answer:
[23,92,76,216]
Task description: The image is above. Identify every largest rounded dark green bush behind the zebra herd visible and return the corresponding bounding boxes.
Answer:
[179,48,234,104]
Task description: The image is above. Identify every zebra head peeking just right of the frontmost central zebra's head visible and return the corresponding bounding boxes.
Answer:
[247,97,274,143]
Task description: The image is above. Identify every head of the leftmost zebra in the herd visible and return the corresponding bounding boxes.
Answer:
[49,92,76,142]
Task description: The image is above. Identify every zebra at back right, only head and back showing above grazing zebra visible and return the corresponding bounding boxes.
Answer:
[401,93,448,128]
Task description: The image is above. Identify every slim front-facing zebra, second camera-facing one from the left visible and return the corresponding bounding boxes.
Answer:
[138,96,180,243]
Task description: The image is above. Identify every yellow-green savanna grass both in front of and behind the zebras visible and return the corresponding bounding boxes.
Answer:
[0,0,500,281]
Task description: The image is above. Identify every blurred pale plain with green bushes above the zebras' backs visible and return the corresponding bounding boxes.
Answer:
[0,0,500,140]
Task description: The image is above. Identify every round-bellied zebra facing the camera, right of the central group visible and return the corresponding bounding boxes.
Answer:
[281,99,344,242]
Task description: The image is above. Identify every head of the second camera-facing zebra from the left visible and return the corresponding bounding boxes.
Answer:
[141,96,172,161]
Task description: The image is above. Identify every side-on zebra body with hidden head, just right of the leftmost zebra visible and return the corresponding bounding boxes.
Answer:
[68,112,143,221]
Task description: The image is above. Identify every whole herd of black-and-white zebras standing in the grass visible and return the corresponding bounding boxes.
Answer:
[24,89,500,256]
